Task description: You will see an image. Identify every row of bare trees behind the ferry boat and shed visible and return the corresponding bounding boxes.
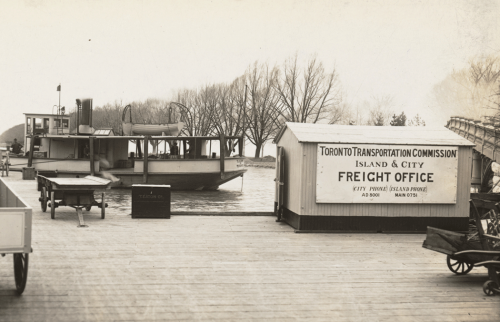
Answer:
[64,56,346,157]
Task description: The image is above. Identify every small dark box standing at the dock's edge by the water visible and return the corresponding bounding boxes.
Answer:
[132,184,170,219]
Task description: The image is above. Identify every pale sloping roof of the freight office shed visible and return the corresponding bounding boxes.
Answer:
[273,122,475,146]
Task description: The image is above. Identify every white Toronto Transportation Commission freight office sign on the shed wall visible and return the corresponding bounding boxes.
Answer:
[316,144,458,204]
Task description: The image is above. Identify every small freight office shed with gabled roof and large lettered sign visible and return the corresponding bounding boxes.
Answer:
[274,123,474,232]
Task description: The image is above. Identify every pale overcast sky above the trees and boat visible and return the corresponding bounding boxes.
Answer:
[0,0,500,132]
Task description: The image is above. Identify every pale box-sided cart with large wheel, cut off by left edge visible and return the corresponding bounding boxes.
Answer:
[0,178,33,295]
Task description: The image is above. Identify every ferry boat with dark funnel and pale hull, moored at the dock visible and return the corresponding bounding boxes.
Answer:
[10,99,246,190]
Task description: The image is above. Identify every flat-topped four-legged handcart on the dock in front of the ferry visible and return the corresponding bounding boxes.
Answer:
[37,174,111,226]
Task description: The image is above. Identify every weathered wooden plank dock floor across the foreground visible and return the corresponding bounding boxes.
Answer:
[0,173,500,321]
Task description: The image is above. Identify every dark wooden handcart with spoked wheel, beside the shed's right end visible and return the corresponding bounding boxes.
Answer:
[422,195,500,295]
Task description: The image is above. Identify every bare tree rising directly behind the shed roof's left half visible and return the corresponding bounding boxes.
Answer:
[273,55,341,123]
